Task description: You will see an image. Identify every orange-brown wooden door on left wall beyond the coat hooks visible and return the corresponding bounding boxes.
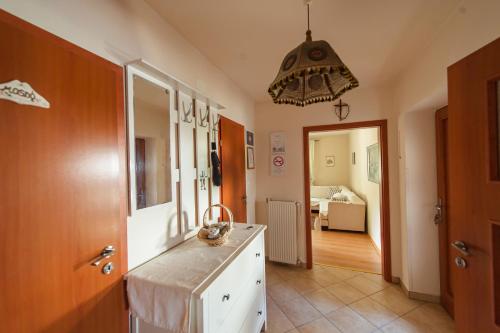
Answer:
[219,116,247,223]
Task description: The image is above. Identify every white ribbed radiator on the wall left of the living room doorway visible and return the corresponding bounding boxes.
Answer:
[267,199,299,265]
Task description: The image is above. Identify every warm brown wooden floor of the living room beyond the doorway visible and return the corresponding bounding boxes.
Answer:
[311,230,382,274]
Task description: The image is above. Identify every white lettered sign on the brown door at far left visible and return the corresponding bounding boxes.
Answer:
[0,80,50,109]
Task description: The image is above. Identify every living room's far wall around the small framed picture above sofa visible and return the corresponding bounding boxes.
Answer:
[314,134,351,185]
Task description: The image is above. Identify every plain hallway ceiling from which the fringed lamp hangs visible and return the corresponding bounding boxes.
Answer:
[145,0,461,102]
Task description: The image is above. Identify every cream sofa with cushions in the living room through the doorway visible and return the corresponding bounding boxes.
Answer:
[311,185,366,232]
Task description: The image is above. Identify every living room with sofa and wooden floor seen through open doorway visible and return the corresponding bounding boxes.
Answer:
[309,127,381,274]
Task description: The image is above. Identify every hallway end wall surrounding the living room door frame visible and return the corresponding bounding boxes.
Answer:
[255,88,401,276]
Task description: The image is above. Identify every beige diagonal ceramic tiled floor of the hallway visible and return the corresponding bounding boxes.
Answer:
[266,263,455,333]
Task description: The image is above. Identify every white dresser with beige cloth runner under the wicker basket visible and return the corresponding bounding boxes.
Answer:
[127,223,266,333]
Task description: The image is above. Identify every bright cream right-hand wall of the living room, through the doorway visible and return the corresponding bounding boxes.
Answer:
[349,128,382,250]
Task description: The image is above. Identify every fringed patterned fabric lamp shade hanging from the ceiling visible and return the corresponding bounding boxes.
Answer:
[268,30,359,106]
